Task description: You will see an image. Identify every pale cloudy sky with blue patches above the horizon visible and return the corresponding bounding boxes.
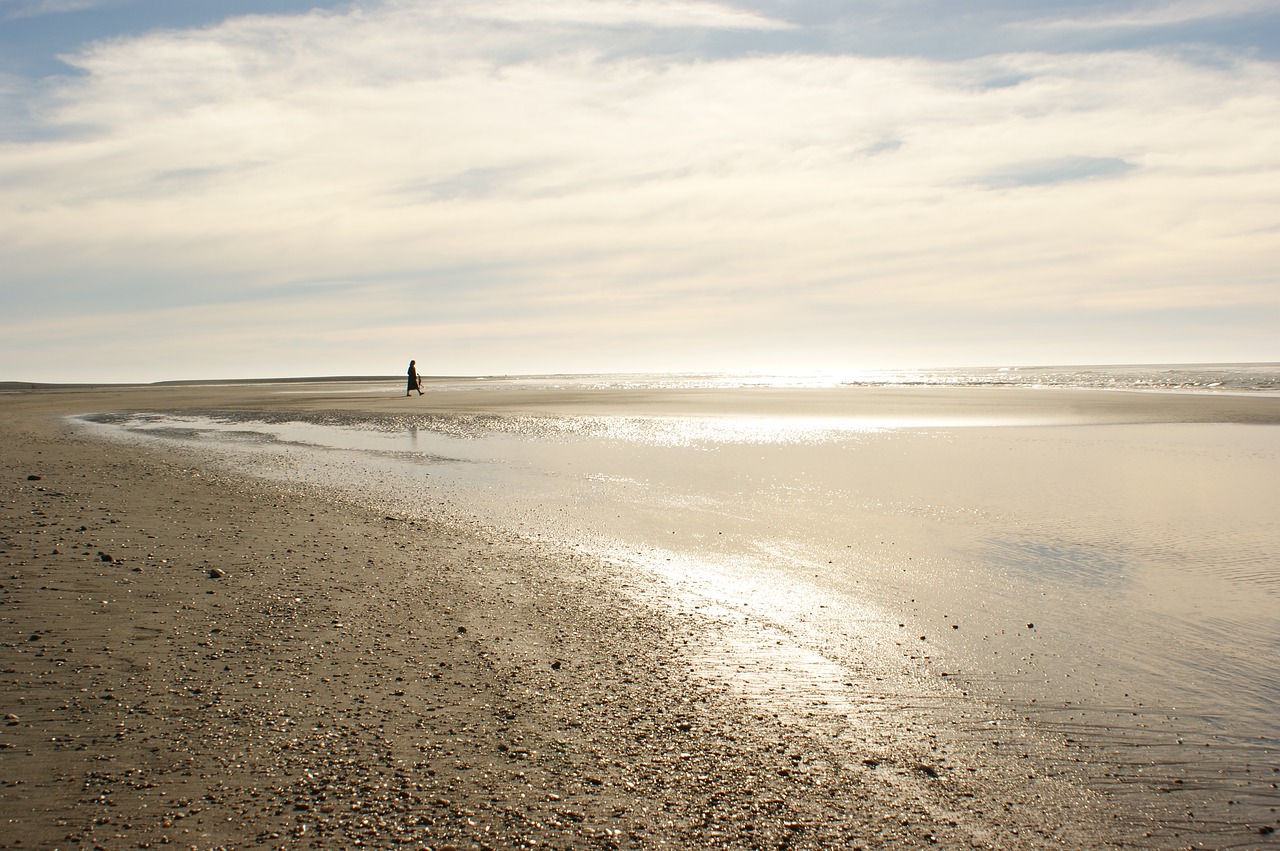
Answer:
[0,0,1280,381]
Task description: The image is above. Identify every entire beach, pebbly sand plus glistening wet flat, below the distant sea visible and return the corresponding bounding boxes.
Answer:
[0,384,1280,847]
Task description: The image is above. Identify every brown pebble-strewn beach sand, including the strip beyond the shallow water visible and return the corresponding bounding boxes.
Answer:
[0,385,1280,848]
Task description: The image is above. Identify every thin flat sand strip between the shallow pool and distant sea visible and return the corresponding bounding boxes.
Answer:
[10,379,1280,425]
